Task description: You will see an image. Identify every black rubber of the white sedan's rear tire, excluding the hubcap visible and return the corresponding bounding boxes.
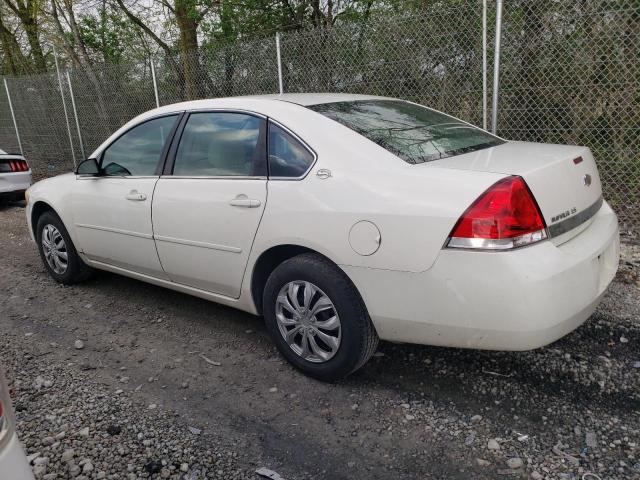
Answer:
[263,253,378,382]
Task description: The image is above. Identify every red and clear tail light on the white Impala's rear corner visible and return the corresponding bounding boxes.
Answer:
[447,176,547,250]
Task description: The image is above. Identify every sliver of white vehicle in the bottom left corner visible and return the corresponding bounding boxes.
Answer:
[0,369,33,480]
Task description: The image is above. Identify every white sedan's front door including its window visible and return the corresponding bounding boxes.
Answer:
[71,114,178,279]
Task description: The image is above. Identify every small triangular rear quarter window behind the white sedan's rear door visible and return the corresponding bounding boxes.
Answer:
[269,123,313,178]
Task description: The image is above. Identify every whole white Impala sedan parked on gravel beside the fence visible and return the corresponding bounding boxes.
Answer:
[27,94,619,380]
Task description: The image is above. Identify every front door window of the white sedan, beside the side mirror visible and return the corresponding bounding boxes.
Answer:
[101,115,178,176]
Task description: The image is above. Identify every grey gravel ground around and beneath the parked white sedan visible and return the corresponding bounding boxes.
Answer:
[0,204,640,480]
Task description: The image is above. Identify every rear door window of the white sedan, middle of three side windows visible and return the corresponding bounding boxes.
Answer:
[173,112,265,177]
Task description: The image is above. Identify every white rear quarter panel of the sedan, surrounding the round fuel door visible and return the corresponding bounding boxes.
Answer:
[252,109,504,272]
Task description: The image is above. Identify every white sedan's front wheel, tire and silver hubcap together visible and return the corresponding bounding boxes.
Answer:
[36,212,93,285]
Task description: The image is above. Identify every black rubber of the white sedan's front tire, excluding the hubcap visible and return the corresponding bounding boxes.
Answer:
[36,211,94,285]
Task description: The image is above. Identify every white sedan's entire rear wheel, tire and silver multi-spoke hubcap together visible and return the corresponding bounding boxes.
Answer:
[263,253,378,381]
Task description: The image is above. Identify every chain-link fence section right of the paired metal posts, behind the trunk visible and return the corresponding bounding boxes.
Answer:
[498,0,640,238]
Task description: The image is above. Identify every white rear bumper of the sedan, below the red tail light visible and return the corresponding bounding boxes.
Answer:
[343,203,620,350]
